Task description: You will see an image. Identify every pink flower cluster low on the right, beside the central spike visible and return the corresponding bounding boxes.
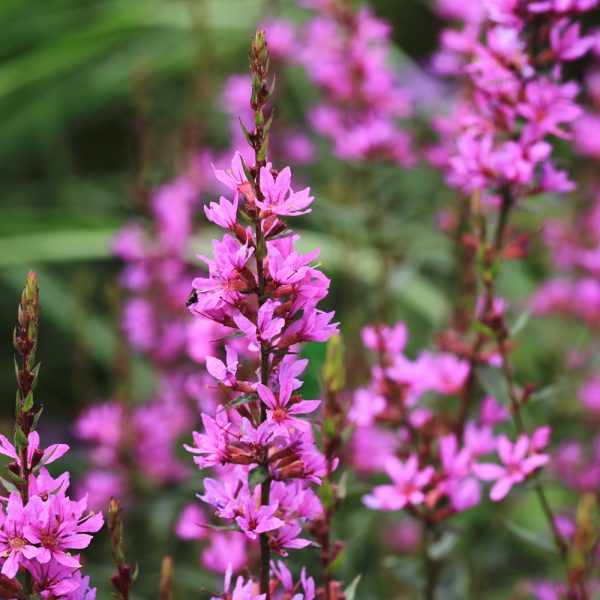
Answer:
[349,323,549,522]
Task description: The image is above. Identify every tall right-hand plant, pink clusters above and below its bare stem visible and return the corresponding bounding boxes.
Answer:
[351,0,597,598]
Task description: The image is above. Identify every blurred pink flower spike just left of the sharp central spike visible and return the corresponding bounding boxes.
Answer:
[75,169,212,506]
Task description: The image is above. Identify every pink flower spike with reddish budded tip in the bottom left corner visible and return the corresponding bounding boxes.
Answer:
[0,272,103,600]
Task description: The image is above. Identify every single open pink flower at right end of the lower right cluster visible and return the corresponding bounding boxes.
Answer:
[473,435,549,502]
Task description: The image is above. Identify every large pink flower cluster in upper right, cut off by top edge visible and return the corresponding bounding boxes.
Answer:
[431,0,597,200]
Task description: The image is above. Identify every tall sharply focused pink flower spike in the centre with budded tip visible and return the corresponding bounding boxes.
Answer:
[187,30,337,600]
